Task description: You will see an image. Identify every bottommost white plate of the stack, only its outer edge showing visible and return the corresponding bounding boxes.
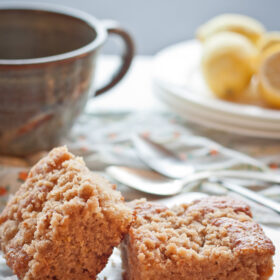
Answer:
[155,84,280,139]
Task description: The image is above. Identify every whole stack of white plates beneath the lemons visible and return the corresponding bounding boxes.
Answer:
[153,40,280,139]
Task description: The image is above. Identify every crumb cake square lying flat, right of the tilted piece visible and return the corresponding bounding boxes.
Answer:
[121,197,275,280]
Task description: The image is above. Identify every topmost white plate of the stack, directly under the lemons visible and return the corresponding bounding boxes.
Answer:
[153,40,280,131]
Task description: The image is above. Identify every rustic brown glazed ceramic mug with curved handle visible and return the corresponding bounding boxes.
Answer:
[0,4,134,156]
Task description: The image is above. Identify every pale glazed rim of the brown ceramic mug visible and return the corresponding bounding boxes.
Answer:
[0,2,107,66]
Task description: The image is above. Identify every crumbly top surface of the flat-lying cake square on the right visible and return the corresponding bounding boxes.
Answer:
[129,197,275,266]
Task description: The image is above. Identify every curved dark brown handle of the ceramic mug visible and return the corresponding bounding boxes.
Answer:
[95,20,135,96]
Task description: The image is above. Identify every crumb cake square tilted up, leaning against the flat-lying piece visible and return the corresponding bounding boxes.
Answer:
[0,147,132,280]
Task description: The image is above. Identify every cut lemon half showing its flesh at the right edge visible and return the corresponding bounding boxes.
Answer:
[259,50,280,108]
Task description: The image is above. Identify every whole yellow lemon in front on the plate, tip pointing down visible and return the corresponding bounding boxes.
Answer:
[202,32,258,100]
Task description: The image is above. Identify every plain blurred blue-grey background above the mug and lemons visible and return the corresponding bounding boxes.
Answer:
[0,0,280,54]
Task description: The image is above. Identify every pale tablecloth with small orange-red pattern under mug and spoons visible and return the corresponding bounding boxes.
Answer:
[0,56,280,279]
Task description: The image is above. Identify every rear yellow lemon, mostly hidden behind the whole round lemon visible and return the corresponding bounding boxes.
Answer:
[196,14,265,44]
